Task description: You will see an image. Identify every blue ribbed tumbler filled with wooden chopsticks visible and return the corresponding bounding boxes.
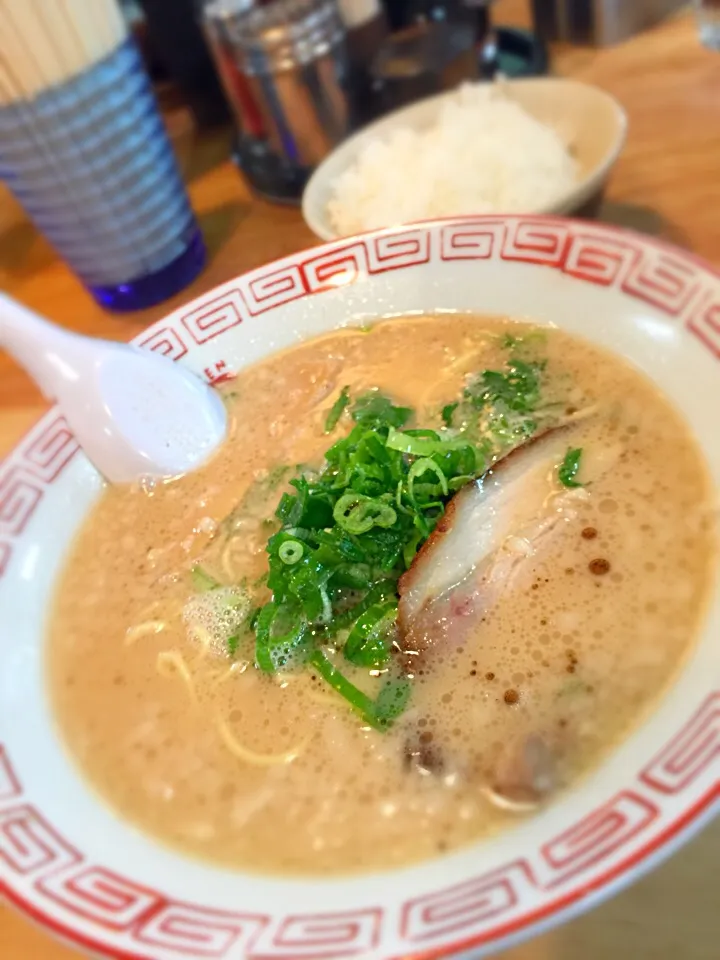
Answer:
[0,0,205,310]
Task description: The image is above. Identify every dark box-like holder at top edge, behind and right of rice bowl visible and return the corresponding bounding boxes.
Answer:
[532,0,686,46]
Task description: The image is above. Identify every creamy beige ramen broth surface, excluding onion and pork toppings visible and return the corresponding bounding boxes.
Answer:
[47,315,714,874]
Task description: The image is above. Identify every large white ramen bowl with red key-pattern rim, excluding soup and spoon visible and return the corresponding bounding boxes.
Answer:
[0,217,720,960]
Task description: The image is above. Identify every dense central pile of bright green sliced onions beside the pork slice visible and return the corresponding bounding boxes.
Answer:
[248,391,485,723]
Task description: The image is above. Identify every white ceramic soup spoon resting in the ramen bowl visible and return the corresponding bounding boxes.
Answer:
[0,293,227,483]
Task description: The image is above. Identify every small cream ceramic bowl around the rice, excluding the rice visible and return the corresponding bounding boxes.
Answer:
[302,77,627,240]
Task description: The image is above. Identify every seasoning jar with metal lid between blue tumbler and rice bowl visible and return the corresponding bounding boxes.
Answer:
[204,0,351,201]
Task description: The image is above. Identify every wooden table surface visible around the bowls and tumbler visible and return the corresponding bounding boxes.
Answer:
[0,0,720,960]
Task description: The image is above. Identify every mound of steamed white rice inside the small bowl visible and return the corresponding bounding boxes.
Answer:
[328,84,578,235]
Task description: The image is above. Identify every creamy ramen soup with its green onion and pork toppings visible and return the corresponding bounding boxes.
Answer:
[47,315,714,874]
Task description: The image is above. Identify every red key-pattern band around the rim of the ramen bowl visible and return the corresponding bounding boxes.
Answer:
[0,217,720,960]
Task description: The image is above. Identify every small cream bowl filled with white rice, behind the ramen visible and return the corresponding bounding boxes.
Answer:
[302,78,627,240]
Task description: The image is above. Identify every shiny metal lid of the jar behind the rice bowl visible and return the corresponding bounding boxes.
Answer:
[227,0,345,74]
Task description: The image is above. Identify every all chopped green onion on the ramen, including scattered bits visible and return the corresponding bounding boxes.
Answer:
[193,337,556,729]
